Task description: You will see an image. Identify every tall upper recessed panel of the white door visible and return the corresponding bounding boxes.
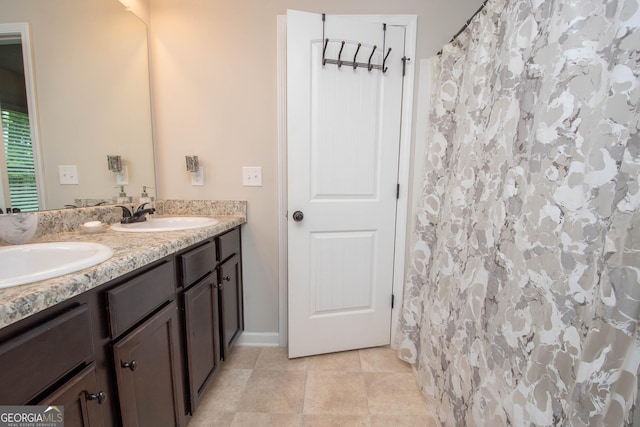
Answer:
[309,41,382,200]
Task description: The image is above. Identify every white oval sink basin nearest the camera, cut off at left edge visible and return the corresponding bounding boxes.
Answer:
[0,242,113,288]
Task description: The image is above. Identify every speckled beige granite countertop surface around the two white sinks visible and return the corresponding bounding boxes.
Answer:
[0,215,247,328]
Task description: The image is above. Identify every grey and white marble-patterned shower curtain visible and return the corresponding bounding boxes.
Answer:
[397,0,640,426]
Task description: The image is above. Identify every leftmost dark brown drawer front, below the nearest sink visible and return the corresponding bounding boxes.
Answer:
[0,305,93,405]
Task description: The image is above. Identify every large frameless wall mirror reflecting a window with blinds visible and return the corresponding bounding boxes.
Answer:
[0,0,155,210]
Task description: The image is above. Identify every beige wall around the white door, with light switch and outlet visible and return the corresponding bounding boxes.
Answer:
[150,0,481,340]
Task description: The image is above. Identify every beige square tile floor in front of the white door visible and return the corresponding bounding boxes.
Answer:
[188,347,436,427]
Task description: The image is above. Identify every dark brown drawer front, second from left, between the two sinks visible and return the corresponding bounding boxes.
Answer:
[106,261,175,338]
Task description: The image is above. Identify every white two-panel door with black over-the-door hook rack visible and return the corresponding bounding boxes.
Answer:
[287,11,404,357]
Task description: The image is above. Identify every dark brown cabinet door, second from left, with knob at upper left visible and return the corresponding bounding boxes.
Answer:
[113,302,184,427]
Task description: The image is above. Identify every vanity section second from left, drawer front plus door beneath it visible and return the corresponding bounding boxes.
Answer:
[105,257,185,427]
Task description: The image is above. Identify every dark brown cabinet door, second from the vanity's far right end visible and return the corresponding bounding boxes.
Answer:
[184,274,220,413]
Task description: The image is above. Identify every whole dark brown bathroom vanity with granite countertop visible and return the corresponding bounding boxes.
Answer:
[0,201,246,427]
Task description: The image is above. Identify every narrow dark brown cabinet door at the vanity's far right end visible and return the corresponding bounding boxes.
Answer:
[219,255,244,359]
